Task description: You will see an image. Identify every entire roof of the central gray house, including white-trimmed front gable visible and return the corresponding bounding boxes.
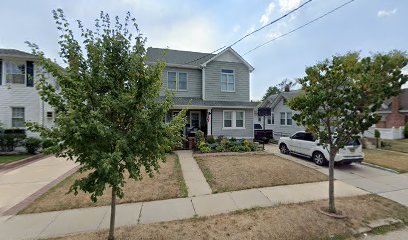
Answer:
[146,47,254,72]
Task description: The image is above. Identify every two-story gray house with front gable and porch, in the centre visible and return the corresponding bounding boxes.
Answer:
[147,48,256,138]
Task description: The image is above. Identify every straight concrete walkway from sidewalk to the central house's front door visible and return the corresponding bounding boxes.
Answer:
[176,150,212,197]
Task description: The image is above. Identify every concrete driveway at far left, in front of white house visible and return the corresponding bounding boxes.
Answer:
[0,156,77,216]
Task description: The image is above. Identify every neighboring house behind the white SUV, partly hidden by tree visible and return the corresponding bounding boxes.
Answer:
[254,90,305,139]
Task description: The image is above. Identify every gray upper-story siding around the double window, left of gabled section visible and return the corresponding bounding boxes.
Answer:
[160,67,202,98]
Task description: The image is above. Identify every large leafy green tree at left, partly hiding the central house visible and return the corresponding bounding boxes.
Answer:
[28,9,185,239]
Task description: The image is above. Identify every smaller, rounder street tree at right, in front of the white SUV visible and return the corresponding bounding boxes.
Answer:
[289,51,408,213]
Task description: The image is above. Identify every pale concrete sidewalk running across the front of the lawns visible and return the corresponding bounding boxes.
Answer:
[0,181,368,239]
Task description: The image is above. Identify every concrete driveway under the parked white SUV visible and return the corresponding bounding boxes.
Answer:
[265,144,408,206]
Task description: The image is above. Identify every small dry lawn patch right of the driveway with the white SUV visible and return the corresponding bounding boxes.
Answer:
[364,149,408,173]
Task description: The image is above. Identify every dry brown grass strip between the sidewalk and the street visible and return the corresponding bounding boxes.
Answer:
[53,195,408,240]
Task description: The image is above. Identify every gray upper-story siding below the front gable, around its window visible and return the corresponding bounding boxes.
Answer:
[205,61,249,102]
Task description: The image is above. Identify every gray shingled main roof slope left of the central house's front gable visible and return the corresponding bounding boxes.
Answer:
[146,47,216,68]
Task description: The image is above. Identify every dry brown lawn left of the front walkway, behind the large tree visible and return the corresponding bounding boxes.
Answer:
[19,155,187,214]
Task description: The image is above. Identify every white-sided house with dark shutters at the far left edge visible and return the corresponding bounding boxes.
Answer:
[0,49,54,135]
